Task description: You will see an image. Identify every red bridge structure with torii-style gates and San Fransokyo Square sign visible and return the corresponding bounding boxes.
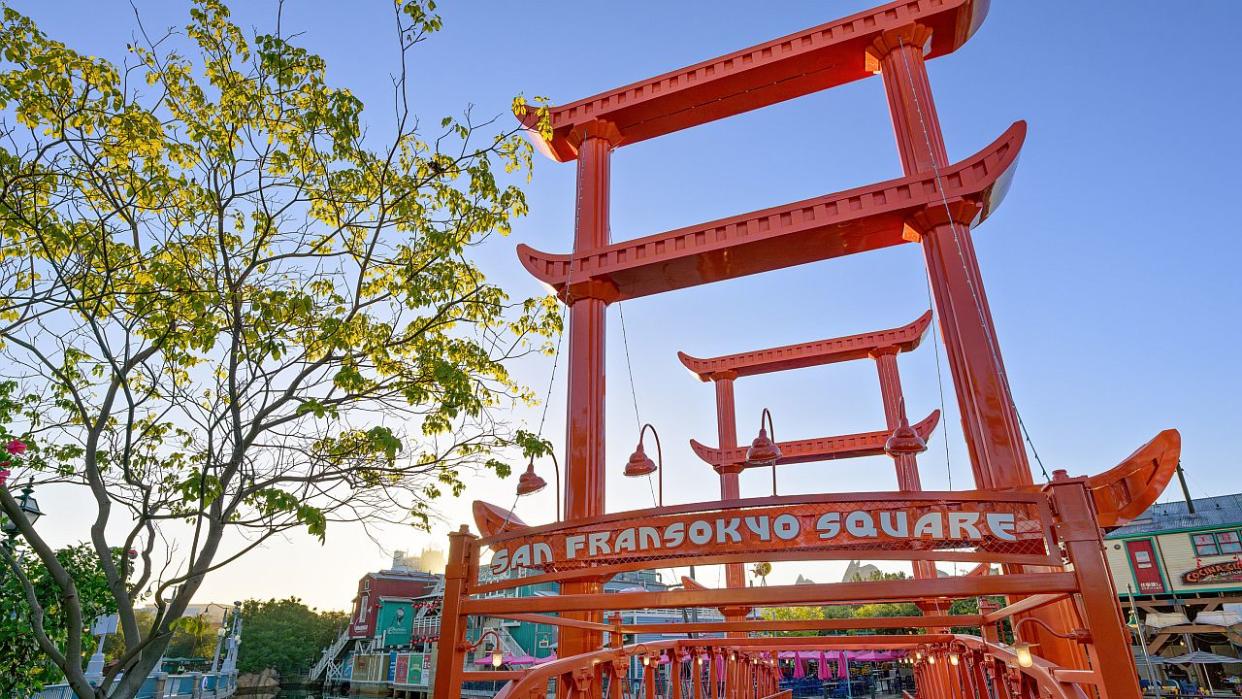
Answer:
[435,0,1180,699]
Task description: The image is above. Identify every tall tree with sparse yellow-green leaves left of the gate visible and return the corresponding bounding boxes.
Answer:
[0,0,560,697]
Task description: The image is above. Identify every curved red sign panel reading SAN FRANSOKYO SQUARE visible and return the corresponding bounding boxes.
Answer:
[491,503,1043,575]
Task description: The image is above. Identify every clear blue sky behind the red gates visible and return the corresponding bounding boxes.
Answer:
[12,0,1242,607]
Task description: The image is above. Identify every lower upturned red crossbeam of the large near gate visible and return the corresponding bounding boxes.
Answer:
[518,122,1026,302]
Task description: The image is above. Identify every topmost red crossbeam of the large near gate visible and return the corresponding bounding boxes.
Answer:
[519,0,987,161]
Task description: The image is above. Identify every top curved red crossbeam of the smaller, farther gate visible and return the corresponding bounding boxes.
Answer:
[677,310,932,381]
